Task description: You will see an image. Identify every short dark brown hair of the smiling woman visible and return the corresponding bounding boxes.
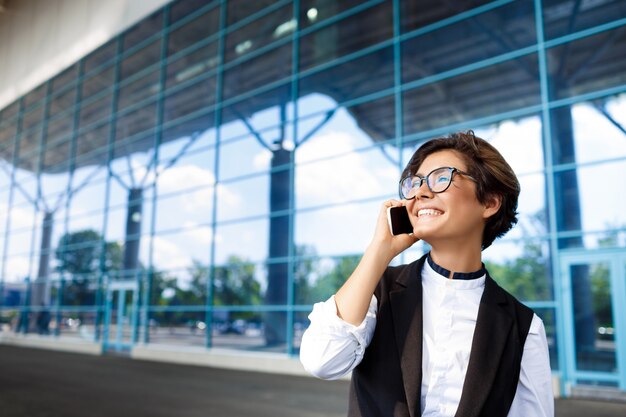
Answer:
[402,130,520,249]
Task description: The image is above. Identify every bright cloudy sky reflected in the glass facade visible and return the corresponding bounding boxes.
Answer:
[0,95,626,281]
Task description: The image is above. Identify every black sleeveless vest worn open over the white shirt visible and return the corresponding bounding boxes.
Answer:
[348,256,533,417]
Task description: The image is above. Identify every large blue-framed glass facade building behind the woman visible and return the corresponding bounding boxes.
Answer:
[0,0,626,393]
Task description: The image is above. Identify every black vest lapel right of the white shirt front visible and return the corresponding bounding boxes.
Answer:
[456,275,513,417]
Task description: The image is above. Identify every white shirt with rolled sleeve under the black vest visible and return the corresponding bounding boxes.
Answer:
[300,262,554,417]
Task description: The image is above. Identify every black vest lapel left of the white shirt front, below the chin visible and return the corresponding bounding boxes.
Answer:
[389,257,426,417]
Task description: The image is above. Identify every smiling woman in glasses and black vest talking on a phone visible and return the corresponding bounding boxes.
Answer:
[300,131,554,417]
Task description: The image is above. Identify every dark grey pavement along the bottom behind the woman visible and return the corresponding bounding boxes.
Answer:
[0,345,626,417]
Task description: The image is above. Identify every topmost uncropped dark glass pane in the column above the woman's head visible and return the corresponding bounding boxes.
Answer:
[402,1,538,83]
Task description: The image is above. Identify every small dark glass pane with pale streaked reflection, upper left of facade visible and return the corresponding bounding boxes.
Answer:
[165,42,219,88]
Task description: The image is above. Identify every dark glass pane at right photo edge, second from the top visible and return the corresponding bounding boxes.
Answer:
[546,26,626,100]
